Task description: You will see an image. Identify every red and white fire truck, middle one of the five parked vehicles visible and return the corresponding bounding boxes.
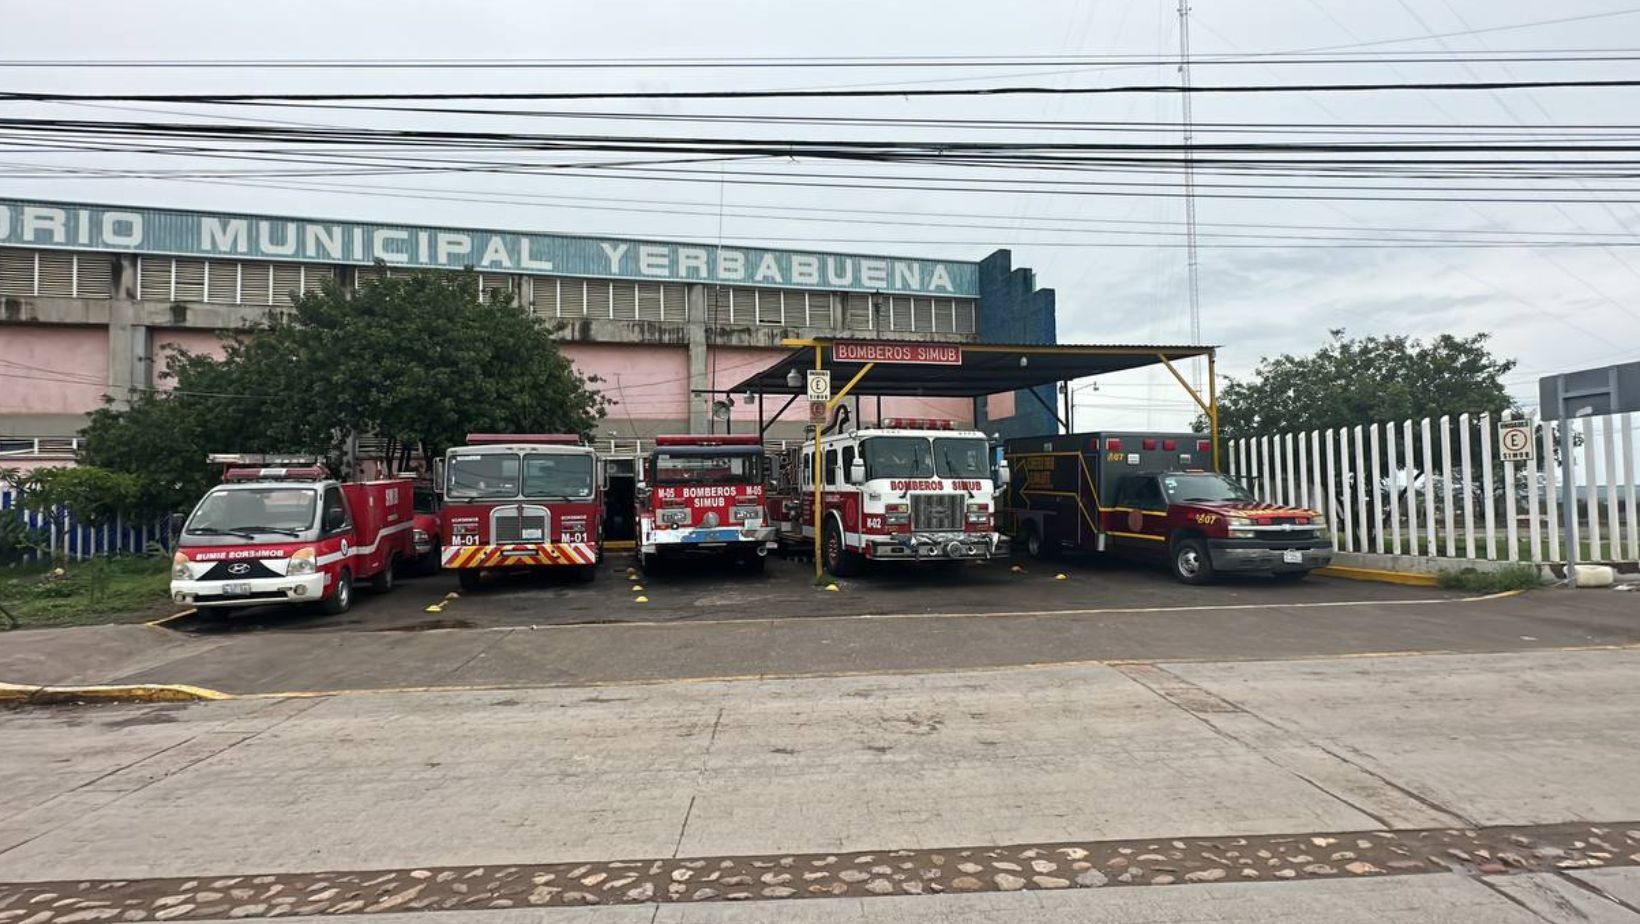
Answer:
[636,435,779,571]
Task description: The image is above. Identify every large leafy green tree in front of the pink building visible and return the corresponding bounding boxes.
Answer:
[82,272,605,510]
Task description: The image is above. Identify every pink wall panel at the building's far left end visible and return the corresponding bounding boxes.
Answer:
[0,325,108,414]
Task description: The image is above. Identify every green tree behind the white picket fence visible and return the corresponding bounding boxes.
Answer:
[1219,330,1515,438]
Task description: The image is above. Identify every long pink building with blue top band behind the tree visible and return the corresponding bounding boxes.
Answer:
[0,199,1055,461]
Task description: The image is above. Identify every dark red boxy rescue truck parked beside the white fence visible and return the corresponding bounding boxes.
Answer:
[1002,433,1333,584]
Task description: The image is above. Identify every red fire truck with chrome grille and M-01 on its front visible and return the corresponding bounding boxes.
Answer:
[440,433,604,589]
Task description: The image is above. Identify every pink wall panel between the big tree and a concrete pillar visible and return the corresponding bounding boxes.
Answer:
[559,343,689,437]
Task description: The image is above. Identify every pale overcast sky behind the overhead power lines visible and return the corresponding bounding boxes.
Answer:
[0,0,1640,427]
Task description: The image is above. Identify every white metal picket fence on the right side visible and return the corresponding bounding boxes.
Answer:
[1223,414,1640,565]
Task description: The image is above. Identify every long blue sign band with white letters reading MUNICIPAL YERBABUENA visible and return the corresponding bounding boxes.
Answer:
[0,199,979,299]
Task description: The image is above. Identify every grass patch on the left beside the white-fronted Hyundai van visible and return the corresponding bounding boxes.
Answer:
[0,555,174,629]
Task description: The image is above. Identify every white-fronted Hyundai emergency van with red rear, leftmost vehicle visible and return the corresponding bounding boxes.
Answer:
[171,455,413,614]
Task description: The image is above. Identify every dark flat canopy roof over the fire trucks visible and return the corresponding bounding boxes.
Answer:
[728,338,1215,397]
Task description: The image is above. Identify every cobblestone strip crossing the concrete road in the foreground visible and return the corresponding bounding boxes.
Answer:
[0,822,1640,924]
